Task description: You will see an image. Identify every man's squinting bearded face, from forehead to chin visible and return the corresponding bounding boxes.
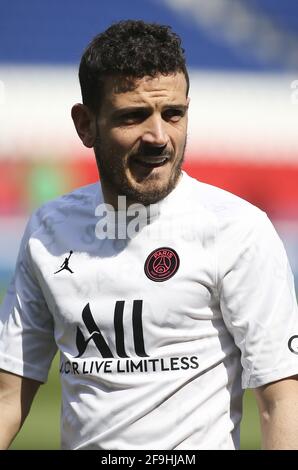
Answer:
[94,73,188,205]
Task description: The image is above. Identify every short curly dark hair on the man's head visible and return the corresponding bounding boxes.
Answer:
[79,20,189,112]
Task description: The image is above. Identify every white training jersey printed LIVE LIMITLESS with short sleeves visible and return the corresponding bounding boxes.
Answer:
[0,173,298,450]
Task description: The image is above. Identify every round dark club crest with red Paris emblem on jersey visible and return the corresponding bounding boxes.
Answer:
[144,247,180,282]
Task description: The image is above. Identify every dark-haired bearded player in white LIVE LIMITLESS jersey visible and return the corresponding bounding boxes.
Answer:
[0,21,298,449]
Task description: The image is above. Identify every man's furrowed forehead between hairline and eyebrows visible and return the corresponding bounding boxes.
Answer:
[104,72,187,103]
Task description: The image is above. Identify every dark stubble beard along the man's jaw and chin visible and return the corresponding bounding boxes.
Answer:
[94,138,186,206]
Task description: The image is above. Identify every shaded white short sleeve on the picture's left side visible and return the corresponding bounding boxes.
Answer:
[0,213,57,382]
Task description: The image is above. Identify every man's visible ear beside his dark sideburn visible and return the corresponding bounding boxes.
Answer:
[71,103,96,148]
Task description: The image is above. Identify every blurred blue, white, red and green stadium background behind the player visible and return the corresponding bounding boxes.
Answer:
[0,0,298,449]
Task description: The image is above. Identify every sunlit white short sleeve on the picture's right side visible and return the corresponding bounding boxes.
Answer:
[218,211,298,388]
